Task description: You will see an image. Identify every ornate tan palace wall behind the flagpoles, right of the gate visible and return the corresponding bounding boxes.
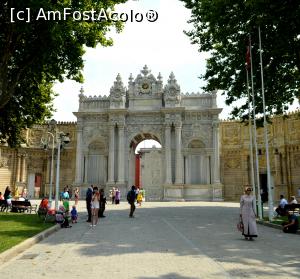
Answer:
[220,113,300,201]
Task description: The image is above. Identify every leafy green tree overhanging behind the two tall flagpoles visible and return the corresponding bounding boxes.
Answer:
[181,0,300,118]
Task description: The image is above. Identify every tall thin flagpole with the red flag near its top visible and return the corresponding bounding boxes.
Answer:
[249,36,263,220]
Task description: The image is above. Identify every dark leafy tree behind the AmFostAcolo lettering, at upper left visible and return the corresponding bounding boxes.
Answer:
[0,0,127,146]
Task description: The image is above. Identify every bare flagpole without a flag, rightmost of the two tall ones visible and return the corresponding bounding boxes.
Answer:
[258,26,274,221]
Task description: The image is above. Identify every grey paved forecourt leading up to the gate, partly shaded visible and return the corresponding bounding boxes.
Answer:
[0,202,300,279]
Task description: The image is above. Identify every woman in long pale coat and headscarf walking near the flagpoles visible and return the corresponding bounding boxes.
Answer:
[240,187,257,240]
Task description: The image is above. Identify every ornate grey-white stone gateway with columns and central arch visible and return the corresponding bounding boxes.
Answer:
[74,66,223,200]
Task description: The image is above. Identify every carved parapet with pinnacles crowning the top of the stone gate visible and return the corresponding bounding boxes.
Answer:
[75,65,222,114]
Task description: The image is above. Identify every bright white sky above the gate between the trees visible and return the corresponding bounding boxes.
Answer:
[53,0,229,121]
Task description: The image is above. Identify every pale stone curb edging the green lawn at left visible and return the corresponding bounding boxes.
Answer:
[0,225,60,265]
